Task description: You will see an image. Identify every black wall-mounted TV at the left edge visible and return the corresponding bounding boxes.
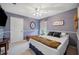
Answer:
[0,6,7,26]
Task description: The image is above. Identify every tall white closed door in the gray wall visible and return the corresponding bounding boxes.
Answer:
[10,17,24,43]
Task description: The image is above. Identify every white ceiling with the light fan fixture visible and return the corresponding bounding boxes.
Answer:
[1,3,77,19]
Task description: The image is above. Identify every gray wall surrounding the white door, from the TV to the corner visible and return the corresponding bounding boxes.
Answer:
[3,12,40,38]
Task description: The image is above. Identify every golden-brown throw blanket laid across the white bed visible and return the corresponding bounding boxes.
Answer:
[30,36,61,49]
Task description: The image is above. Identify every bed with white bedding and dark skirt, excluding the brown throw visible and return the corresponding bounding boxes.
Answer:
[30,35,69,55]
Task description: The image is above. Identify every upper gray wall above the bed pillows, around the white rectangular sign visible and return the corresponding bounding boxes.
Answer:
[47,9,77,32]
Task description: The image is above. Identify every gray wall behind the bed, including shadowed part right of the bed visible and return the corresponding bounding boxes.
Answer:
[42,9,77,45]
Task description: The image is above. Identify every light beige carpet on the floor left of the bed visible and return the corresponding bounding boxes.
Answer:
[8,40,35,55]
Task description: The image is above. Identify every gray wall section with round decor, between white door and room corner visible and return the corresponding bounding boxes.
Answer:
[24,18,40,36]
